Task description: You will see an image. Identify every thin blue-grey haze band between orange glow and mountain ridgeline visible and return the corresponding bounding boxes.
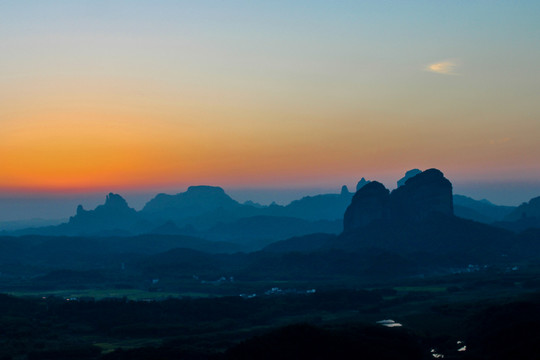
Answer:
[0,179,540,224]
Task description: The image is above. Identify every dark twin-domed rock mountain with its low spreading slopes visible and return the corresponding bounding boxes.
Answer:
[268,169,540,266]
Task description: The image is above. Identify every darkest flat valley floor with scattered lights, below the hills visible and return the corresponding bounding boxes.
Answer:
[0,264,540,359]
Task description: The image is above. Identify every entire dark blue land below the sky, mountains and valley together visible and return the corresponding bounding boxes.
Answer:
[0,169,540,359]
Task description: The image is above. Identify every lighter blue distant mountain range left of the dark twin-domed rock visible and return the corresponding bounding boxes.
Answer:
[4,186,353,246]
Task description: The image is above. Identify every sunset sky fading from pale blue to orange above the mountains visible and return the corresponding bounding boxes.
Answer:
[0,0,540,218]
